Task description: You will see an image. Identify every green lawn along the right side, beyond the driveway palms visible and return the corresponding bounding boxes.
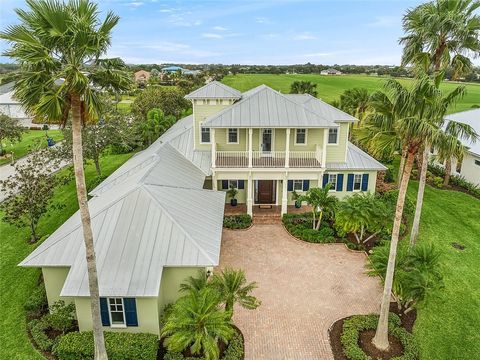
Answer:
[408,182,480,360]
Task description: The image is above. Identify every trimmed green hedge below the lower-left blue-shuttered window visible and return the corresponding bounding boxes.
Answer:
[53,331,158,360]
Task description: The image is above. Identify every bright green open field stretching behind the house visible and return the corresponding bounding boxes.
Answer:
[222,74,480,112]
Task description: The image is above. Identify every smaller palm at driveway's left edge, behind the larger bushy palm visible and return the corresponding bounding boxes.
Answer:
[212,268,260,313]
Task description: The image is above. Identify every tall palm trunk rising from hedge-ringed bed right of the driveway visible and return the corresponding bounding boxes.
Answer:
[372,152,415,350]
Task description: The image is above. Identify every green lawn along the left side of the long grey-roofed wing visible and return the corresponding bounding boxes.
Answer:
[0,154,131,360]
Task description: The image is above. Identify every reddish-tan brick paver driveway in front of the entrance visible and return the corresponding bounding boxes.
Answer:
[220,225,382,360]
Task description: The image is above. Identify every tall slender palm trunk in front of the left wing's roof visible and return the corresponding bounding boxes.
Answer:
[72,94,107,360]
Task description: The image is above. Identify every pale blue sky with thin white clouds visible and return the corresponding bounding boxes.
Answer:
[0,0,479,65]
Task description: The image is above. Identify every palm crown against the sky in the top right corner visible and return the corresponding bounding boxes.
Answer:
[399,0,480,77]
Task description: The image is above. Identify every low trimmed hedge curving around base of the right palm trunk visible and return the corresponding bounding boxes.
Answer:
[340,313,418,360]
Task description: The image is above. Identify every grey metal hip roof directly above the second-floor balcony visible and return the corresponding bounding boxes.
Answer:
[205,85,338,128]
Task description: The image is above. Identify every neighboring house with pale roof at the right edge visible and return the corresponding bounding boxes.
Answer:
[445,109,480,186]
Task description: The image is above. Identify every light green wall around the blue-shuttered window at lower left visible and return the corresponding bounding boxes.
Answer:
[75,297,160,335]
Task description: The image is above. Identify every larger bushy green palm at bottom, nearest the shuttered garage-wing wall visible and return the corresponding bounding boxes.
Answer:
[161,286,235,360]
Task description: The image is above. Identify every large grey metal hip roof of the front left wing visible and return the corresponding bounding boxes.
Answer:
[20,184,225,297]
